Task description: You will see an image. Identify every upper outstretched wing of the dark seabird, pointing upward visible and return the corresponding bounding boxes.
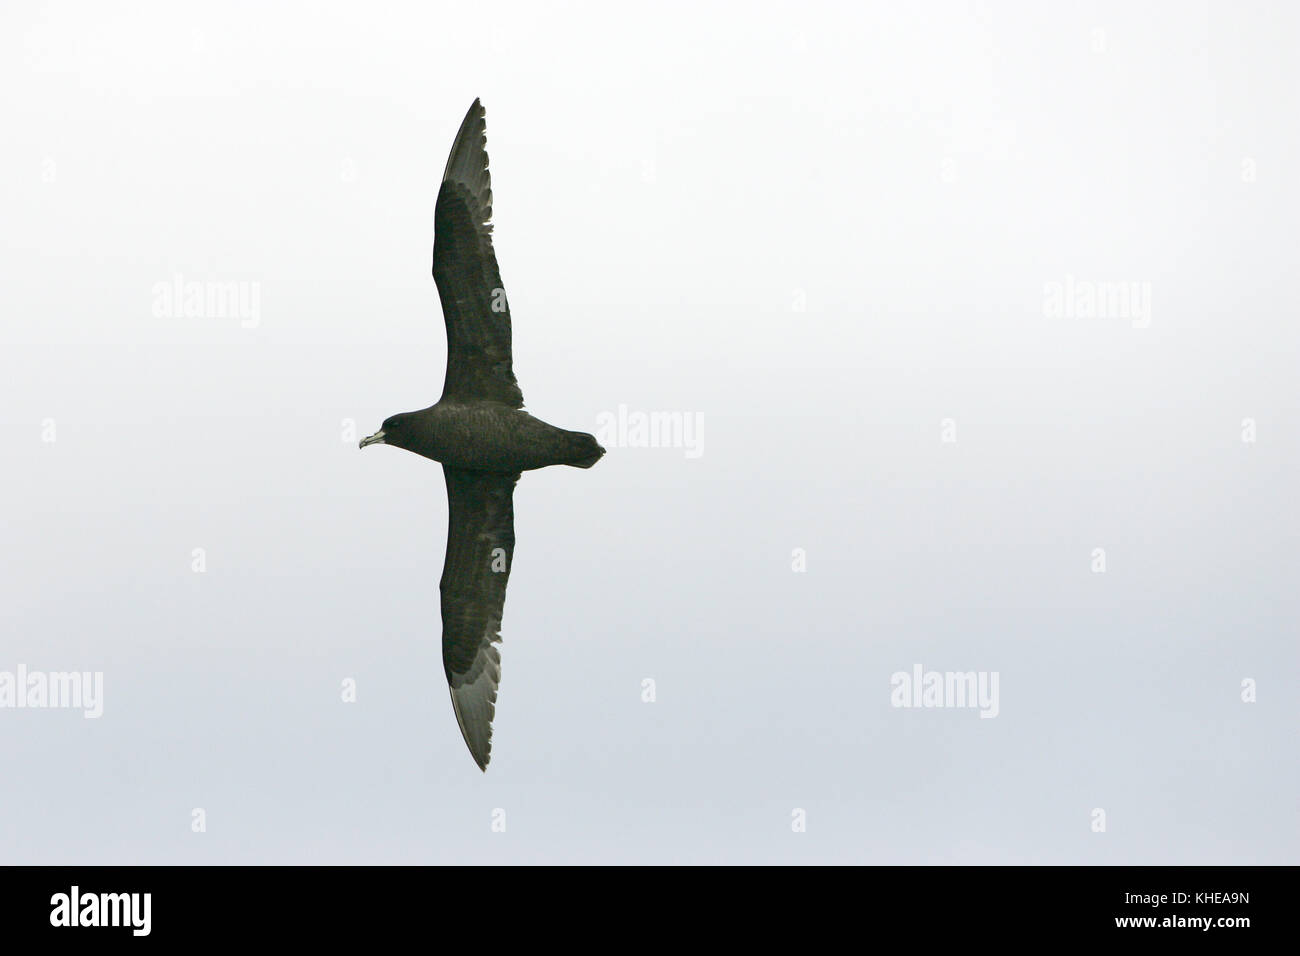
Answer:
[433,100,524,408]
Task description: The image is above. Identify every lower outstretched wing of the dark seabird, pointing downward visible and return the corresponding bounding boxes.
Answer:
[442,466,519,770]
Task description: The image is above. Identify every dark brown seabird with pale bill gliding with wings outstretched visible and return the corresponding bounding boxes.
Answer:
[360,100,605,770]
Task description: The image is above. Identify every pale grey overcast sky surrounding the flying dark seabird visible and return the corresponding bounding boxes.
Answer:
[0,3,1300,864]
